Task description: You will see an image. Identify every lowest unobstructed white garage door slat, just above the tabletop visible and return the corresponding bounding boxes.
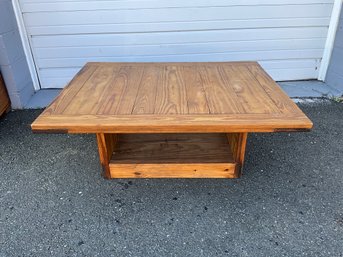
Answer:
[36,38,325,59]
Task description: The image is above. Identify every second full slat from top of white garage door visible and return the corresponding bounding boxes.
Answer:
[27,17,330,35]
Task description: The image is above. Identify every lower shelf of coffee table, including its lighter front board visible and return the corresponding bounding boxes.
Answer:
[109,134,239,178]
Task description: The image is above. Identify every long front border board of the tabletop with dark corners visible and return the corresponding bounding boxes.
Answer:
[31,114,312,133]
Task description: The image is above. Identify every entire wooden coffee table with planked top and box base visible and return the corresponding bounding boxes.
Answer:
[32,62,312,178]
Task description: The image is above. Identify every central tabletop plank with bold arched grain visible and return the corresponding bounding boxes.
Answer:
[154,64,188,114]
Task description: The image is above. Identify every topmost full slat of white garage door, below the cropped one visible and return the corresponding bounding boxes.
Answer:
[24,4,332,27]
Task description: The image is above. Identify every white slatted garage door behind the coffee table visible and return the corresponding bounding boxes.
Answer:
[19,0,333,88]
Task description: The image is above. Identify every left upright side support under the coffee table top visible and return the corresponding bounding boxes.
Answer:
[96,133,118,179]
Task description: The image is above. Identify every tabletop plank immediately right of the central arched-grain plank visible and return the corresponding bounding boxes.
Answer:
[180,65,210,114]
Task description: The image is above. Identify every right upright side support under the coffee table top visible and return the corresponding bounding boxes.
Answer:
[227,133,248,177]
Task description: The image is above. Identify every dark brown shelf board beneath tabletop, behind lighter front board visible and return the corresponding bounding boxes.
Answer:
[111,134,234,164]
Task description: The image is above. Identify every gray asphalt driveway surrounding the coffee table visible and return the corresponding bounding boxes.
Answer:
[0,103,343,257]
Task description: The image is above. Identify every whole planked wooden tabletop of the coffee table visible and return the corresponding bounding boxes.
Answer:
[32,62,312,133]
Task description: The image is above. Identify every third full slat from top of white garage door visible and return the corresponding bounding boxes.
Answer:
[31,27,327,48]
